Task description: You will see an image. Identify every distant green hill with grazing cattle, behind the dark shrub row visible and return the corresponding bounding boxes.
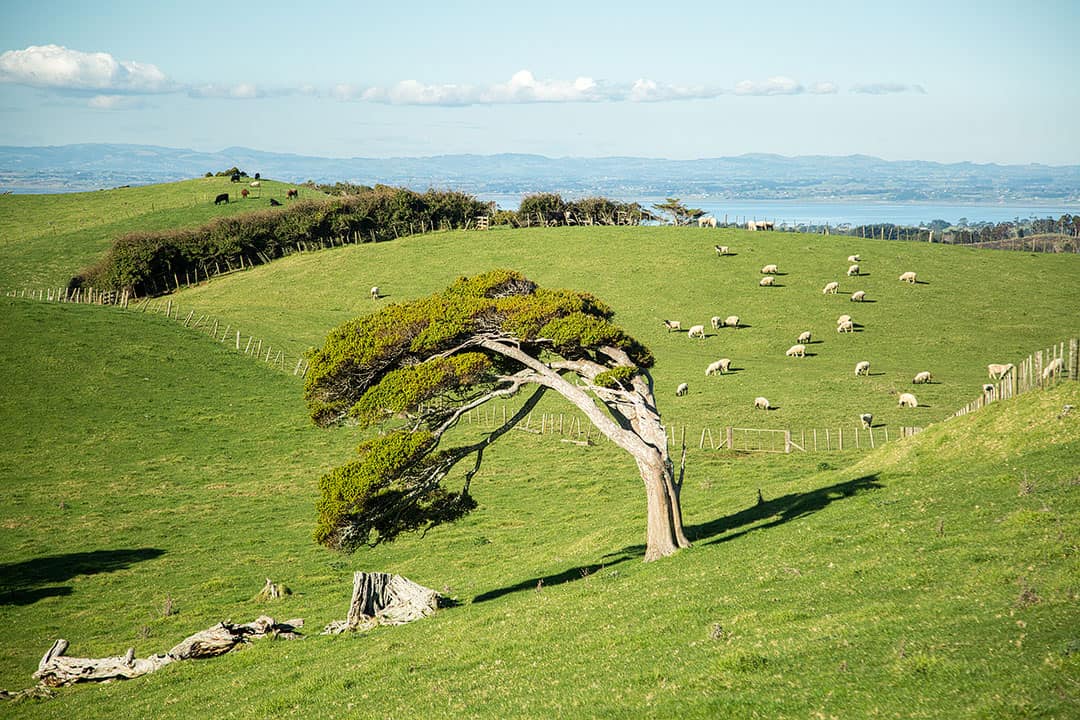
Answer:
[0,177,314,289]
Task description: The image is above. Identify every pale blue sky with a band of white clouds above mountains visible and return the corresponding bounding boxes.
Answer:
[0,0,1080,165]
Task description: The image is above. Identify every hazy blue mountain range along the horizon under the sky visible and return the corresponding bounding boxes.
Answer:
[0,145,1080,203]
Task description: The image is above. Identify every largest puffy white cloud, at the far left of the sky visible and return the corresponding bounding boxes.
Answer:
[0,45,175,93]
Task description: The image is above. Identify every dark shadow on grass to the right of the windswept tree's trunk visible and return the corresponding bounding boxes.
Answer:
[686,474,882,545]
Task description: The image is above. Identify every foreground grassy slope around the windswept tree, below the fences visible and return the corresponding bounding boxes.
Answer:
[0,299,1080,718]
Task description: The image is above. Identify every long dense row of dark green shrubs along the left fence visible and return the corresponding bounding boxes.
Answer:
[69,186,494,296]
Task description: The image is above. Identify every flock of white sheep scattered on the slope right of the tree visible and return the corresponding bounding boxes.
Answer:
[663,245,950,427]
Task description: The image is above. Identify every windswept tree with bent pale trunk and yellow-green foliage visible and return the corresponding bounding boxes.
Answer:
[305,270,690,560]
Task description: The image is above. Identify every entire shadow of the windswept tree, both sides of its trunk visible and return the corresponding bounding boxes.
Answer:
[473,474,882,602]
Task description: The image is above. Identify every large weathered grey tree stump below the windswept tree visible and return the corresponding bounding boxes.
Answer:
[323,572,440,635]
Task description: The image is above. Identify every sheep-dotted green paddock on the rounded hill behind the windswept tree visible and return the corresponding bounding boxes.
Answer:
[168,222,1080,431]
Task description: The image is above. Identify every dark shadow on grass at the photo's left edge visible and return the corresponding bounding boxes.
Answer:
[0,547,165,606]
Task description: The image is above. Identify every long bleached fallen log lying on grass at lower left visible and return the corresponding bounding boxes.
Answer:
[33,615,303,688]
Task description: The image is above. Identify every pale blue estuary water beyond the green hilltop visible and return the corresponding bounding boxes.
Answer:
[477,194,1080,227]
